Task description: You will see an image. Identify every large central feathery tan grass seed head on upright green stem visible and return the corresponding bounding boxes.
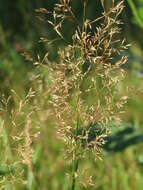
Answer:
[36,0,128,189]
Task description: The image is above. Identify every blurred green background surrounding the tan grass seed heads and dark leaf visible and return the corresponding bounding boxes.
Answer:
[0,0,143,190]
